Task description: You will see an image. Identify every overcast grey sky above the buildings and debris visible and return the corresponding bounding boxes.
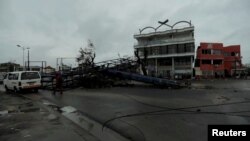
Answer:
[0,0,250,66]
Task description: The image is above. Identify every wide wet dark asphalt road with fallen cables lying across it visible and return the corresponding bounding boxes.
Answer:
[0,80,250,141]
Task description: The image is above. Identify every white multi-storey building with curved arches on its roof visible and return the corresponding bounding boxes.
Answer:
[134,21,195,78]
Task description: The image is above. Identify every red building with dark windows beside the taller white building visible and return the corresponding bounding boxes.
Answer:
[195,43,242,78]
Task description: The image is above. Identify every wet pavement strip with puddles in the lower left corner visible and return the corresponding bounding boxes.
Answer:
[0,92,97,141]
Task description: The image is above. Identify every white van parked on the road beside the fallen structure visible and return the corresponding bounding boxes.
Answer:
[3,71,41,92]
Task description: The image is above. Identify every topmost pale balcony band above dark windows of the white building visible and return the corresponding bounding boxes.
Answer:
[134,37,194,48]
